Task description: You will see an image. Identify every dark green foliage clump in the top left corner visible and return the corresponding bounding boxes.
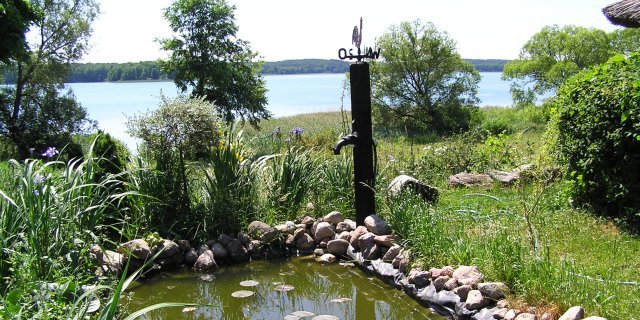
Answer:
[0,0,39,63]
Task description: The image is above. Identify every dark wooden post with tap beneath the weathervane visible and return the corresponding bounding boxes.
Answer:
[349,61,376,226]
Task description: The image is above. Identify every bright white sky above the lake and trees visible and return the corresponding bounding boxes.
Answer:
[83,0,617,62]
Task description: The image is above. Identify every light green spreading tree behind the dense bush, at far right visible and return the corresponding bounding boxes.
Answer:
[503,25,613,105]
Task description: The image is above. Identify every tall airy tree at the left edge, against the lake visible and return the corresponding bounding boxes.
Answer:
[0,0,98,157]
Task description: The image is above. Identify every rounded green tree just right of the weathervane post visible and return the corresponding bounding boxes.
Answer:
[372,20,480,133]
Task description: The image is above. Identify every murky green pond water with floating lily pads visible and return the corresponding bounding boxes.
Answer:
[123,257,445,320]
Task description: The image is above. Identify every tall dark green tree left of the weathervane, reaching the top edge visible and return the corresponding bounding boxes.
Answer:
[160,0,271,124]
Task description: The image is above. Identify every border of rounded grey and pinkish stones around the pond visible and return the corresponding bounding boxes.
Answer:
[90,211,606,320]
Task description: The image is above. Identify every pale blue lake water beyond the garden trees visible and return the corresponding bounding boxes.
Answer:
[68,72,511,149]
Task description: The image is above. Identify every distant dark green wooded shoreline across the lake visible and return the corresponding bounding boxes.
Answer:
[4,59,510,84]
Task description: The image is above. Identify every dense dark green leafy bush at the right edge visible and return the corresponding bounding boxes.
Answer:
[555,53,640,225]
